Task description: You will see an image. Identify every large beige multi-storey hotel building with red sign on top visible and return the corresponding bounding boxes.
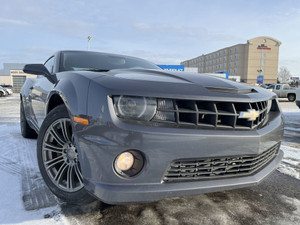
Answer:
[180,37,281,83]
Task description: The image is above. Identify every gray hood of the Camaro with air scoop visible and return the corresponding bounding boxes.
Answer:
[88,69,274,101]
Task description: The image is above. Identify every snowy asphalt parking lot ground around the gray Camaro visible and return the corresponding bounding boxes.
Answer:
[0,94,300,225]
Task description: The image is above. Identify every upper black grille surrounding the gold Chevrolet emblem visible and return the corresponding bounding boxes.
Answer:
[151,99,276,129]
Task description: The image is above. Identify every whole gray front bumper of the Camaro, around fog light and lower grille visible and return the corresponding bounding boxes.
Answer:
[75,104,283,204]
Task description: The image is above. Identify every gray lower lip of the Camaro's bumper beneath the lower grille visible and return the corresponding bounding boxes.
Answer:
[86,150,283,204]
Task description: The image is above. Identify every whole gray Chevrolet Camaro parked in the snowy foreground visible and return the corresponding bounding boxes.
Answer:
[20,51,283,204]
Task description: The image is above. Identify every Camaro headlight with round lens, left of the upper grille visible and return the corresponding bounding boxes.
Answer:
[114,96,157,121]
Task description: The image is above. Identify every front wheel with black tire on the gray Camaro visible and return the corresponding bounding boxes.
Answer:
[37,105,95,204]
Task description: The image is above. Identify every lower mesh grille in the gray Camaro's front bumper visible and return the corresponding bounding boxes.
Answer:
[163,143,280,182]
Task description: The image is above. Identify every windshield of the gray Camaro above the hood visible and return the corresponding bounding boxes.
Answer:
[60,52,160,71]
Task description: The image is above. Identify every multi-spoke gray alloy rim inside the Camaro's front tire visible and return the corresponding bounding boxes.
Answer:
[42,118,84,192]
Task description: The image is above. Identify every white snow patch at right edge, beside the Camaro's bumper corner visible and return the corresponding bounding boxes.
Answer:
[278,145,300,180]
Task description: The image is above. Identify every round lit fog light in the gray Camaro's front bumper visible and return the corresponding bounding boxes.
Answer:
[114,150,145,177]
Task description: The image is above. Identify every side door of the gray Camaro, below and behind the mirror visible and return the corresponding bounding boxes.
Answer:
[30,56,55,128]
